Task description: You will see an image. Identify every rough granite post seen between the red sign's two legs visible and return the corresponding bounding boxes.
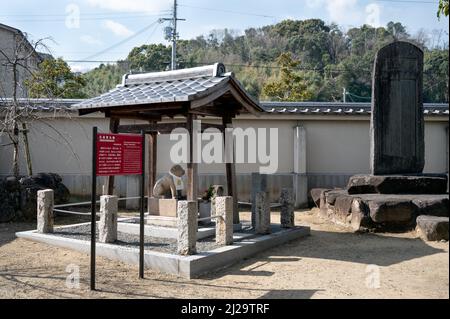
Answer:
[98,195,119,243]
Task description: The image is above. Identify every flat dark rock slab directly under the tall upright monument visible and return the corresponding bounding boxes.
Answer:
[347,175,447,194]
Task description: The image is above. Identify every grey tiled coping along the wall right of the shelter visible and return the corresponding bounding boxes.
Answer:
[260,102,449,116]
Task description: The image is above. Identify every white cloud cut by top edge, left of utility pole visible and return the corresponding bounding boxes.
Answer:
[87,0,173,13]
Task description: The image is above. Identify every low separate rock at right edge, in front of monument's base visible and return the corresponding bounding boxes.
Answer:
[416,216,449,241]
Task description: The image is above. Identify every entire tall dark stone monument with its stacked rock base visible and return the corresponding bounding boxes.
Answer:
[311,41,449,238]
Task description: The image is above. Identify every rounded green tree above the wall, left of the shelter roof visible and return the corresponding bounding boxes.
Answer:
[25,58,87,99]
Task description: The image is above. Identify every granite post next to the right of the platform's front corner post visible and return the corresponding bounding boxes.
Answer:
[216,196,233,245]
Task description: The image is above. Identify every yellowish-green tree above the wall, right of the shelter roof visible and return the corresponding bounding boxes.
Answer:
[263,53,312,101]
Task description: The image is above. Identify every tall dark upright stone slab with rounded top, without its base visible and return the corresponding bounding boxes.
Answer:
[370,41,425,175]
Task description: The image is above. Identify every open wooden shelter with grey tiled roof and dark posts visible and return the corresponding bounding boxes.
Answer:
[75,63,263,223]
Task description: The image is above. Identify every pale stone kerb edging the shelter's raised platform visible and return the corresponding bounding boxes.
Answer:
[16,225,310,279]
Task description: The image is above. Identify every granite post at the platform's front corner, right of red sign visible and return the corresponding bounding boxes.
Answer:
[178,201,198,256]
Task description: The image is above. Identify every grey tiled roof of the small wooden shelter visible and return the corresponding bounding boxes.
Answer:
[74,63,262,115]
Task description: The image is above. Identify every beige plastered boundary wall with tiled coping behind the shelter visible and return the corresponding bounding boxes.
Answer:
[0,101,449,205]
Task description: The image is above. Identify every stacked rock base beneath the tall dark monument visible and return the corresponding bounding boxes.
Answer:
[311,175,449,236]
